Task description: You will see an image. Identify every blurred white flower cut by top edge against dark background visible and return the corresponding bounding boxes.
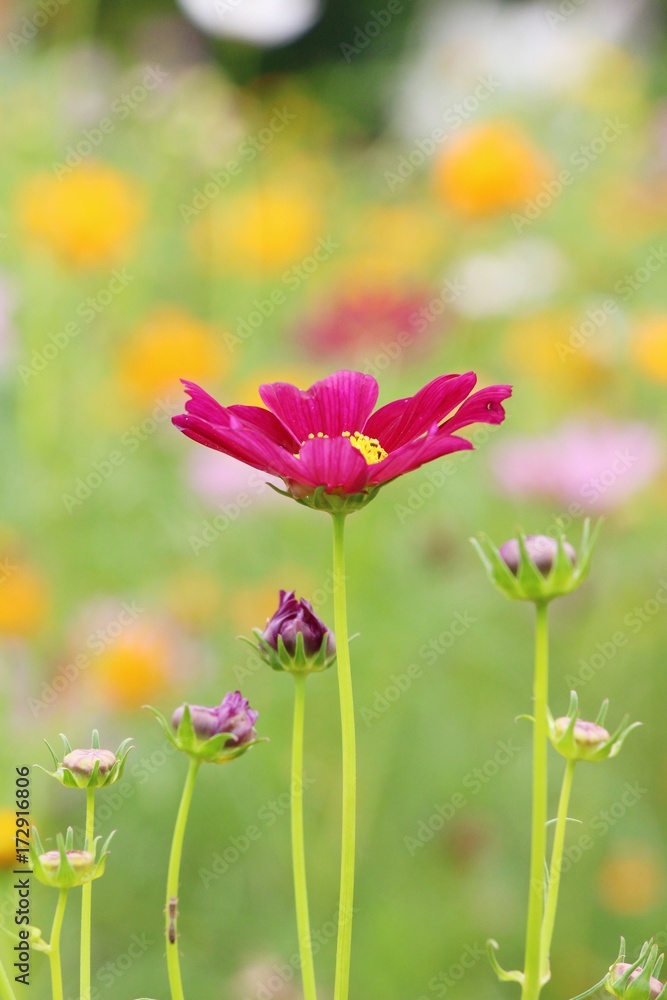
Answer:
[178,0,320,48]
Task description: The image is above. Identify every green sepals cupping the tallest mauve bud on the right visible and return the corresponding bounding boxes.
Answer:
[470,518,602,603]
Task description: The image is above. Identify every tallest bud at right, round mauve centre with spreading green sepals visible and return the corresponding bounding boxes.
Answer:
[471,518,602,603]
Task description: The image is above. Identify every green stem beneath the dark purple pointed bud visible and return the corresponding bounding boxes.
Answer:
[291,673,317,1000]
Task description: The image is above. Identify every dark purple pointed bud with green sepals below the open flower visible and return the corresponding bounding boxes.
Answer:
[254,590,336,673]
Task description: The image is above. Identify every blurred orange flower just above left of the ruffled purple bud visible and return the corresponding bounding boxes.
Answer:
[91,622,174,709]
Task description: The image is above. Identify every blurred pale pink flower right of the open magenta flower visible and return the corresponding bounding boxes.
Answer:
[491,421,663,511]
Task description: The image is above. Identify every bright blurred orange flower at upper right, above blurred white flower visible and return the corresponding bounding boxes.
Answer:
[434,122,552,216]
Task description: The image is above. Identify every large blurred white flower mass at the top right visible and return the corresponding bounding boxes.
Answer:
[393,0,648,139]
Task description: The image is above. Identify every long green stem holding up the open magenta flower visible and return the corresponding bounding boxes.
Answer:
[332,514,357,1000]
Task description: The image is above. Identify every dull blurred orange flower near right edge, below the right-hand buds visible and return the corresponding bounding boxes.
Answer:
[598,844,663,917]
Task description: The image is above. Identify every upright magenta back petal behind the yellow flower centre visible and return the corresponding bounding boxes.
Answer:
[259,371,378,443]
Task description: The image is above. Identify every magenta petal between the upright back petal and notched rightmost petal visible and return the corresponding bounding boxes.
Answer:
[364,372,477,452]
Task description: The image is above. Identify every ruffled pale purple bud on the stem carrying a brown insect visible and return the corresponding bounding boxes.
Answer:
[146,691,262,764]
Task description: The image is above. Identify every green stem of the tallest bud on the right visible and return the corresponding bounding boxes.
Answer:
[521,601,549,1000]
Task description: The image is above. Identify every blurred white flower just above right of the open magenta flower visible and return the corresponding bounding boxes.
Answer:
[454,238,567,319]
